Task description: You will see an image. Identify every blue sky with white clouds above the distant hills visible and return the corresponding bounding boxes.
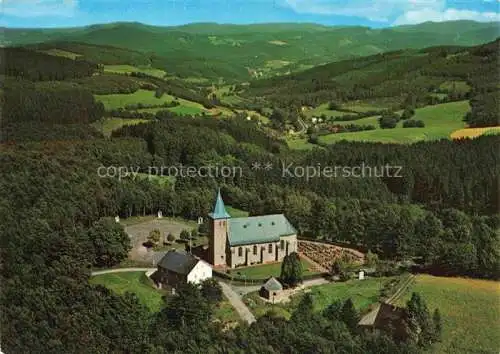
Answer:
[0,0,500,28]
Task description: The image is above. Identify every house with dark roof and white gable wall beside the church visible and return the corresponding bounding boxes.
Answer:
[151,250,212,288]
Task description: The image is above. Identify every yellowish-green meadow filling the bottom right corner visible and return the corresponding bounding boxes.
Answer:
[399,275,500,353]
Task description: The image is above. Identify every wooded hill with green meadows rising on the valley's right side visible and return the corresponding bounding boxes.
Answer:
[246,40,500,144]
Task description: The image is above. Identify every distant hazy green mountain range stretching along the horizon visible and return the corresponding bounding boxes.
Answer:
[0,21,499,81]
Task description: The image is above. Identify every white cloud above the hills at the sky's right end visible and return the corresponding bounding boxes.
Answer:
[394,9,500,25]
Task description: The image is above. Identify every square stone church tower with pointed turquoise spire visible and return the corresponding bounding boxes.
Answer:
[208,188,231,266]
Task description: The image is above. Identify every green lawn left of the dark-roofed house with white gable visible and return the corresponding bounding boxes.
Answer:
[90,272,164,312]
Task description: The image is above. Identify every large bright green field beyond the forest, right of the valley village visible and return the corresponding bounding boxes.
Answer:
[319,101,470,144]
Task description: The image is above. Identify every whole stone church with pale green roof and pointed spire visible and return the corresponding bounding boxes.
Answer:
[208,189,297,268]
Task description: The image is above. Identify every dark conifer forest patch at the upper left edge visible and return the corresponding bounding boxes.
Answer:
[0,48,98,81]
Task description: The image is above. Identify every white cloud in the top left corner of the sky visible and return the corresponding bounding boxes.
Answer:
[0,0,78,17]
